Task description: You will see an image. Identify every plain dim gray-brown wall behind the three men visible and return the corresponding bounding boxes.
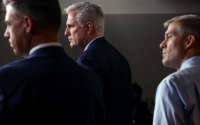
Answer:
[0,0,200,110]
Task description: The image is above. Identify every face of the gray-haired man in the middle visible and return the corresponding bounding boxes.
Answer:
[65,11,87,49]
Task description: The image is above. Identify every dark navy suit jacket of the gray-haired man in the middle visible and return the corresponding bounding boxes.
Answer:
[77,37,131,125]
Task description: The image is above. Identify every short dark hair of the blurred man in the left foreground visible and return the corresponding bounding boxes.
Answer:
[3,0,61,31]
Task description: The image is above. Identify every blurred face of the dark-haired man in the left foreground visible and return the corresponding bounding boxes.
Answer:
[4,4,30,56]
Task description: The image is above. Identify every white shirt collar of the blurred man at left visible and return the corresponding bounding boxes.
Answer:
[29,42,61,55]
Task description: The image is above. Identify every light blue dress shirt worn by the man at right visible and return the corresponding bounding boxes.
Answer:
[153,56,200,125]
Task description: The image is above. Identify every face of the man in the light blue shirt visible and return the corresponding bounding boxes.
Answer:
[160,22,186,69]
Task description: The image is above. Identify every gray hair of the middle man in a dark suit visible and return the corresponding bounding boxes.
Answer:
[65,2,104,34]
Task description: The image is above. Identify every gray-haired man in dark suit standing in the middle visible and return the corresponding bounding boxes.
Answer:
[65,2,131,125]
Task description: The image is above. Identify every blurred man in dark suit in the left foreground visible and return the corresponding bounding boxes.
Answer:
[0,0,104,125]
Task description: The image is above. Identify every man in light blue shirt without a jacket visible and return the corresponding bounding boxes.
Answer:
[153,15,200,125]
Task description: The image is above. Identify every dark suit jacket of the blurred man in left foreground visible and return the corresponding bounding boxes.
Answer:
[0,46,103,125]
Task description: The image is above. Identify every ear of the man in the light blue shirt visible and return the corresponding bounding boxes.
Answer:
[185,35,196,49]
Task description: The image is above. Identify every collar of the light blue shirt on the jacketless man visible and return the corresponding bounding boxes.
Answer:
[180,56,200,70]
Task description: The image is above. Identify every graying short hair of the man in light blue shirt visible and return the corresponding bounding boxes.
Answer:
[163,14,200,42]
